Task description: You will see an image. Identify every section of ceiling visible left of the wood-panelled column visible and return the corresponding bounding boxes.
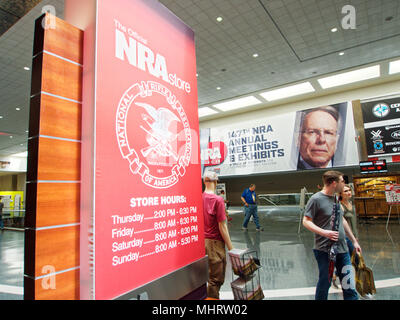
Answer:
[0,0,64,155]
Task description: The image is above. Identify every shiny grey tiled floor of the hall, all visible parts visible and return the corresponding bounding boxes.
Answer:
[0,207,400,300]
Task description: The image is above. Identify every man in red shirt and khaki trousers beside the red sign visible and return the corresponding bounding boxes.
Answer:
[203,171,233,299]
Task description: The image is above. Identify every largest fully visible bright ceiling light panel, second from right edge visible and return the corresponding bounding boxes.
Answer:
[318,65,380,89]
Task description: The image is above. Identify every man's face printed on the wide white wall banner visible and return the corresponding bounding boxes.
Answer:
[300,110,338,168]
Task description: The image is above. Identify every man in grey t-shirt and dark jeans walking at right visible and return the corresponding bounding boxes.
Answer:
[303,171,361,300]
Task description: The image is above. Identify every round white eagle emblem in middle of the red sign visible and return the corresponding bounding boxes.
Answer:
[115,81,192,189]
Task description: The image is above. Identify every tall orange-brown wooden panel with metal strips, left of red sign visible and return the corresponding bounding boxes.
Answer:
[24,14,83,300]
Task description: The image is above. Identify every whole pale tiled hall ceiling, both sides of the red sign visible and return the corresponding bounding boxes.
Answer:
[0,0,400,155]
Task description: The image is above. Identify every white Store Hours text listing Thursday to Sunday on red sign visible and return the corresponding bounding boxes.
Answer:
[110,196,200,267]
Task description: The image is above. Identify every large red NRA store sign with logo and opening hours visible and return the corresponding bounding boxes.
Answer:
[78,0,205,299]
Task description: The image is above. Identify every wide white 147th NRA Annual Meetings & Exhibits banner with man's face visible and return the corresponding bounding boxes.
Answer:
[200,102,359,176]
